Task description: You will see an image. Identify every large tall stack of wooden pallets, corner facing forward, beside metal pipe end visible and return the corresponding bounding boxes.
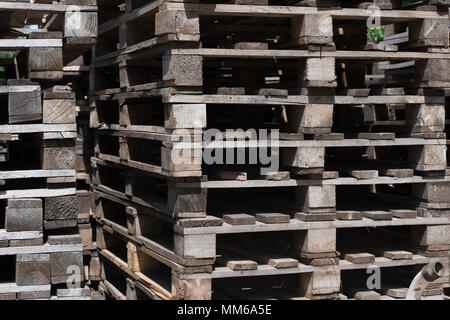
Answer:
[89,0,450,300]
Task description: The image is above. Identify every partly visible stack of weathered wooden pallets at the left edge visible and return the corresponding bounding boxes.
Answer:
[0,0,97,300]
